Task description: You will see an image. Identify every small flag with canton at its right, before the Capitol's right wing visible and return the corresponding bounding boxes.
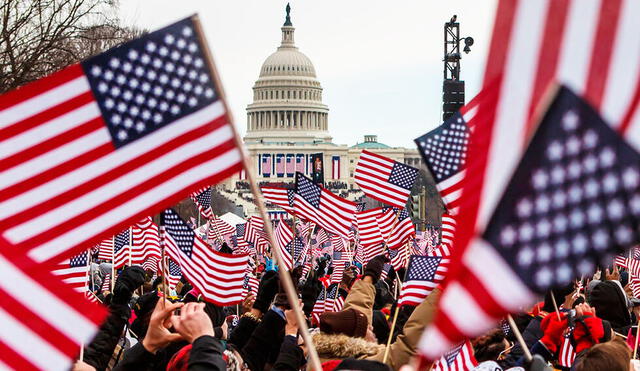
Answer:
[354,150,418,208]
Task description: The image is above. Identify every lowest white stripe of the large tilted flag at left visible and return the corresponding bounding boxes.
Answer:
[29,148,241,262]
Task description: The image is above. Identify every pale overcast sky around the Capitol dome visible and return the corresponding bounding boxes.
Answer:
[120,0,496,147]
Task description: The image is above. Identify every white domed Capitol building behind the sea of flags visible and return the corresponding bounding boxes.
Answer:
[218,6,422,217]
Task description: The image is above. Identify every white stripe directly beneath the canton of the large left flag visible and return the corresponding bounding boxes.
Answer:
[0,101,224,219]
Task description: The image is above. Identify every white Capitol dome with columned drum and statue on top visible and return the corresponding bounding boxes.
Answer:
[244,5,332,144]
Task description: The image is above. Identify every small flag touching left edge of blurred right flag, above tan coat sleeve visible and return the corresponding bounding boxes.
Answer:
[398,255,449,305]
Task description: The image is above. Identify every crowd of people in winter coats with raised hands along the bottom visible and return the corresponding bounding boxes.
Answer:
[75,255,640,371]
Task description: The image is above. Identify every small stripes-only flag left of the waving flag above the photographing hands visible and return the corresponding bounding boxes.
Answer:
[131,217,162,272]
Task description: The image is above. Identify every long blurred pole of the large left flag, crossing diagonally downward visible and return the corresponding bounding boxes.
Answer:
[191,15,322,371]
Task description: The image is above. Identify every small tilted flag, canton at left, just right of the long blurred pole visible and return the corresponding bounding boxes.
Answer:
[293,173,356,238]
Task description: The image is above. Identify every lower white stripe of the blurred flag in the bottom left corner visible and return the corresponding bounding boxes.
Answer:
[0,307,70,370]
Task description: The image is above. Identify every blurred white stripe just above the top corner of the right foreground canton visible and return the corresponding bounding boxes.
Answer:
[556,0,600,96]
